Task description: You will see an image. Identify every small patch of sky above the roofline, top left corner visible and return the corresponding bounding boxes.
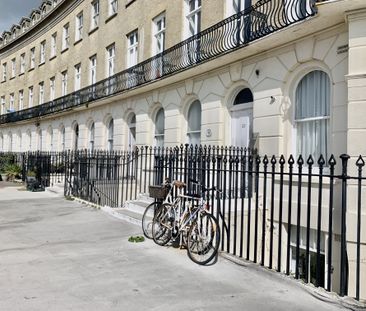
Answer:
[0,0,42,35]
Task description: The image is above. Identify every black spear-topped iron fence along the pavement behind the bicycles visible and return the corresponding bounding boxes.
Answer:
[0,145,366,299]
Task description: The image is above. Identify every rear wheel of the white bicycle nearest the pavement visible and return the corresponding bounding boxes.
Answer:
[152,204,175,246]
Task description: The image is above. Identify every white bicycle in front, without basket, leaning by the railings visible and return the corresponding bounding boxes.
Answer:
[152,181,220,265]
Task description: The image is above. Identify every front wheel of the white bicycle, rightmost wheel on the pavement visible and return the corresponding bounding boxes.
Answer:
[187,213,220,265]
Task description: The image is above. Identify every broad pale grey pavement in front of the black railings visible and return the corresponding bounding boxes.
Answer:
[0,182,354,311]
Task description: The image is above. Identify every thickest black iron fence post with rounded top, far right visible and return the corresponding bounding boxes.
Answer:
[340,154,350,297]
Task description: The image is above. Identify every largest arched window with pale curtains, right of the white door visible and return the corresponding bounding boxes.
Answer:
[295,70,330,162]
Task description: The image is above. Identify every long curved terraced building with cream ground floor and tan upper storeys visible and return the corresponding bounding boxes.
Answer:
[0,0,366,302]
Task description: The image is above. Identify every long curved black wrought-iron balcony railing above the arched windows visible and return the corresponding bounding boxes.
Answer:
[0,0,316,124]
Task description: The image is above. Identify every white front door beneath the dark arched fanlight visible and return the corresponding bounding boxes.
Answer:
[231,109,253,148]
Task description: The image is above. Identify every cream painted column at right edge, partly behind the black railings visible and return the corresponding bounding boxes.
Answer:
[346,9,366,299]
